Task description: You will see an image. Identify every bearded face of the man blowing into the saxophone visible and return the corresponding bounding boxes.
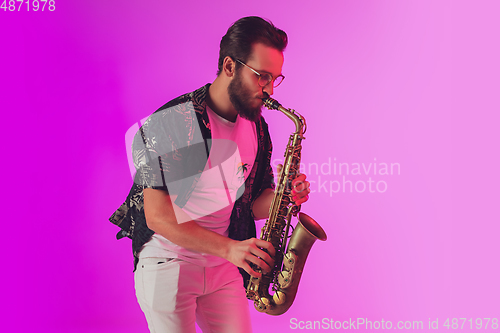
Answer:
[227,43,283,122]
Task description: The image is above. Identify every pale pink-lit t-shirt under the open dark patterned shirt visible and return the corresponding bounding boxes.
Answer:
[139,106,258,267]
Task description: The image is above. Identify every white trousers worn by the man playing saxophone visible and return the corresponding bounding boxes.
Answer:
[134,258,252,333]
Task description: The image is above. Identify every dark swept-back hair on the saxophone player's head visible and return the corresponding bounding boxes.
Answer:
[217,16,288,75]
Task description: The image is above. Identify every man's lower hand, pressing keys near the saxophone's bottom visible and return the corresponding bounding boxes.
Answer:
[226,238,276,277]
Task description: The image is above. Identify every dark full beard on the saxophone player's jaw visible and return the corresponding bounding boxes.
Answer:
[227,72,262,122]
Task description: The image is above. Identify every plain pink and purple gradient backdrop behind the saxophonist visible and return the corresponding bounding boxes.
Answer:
[0,0,500,332]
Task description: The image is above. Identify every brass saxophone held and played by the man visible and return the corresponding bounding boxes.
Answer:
[247,96,326,315]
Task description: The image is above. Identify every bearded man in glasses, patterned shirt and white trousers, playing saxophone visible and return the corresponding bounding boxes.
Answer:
[110,17,309,332]
